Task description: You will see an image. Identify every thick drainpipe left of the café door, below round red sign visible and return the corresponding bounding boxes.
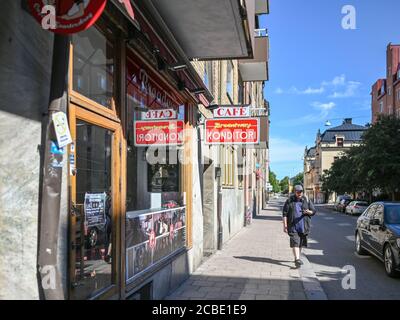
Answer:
[37,34,70,300]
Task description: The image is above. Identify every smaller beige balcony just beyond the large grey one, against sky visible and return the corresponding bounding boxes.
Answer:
[239,29,269,82]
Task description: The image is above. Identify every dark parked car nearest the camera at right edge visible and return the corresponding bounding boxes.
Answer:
[355,202,400,277]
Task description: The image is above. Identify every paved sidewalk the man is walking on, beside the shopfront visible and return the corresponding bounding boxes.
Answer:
[166,202,326,300]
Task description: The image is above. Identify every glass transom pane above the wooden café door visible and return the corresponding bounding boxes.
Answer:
[72,27,114,108]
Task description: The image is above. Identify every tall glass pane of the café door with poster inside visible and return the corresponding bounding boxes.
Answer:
[72,120,114,299]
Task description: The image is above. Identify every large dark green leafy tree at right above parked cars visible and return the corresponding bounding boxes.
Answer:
[322,116,400,200]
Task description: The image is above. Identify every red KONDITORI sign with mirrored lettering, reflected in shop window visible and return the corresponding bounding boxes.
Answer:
[135,120,184,147]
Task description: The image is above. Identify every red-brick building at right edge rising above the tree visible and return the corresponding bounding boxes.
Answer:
[371,43,400,123]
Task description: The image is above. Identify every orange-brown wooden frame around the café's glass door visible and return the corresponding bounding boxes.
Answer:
[68,103,123,299]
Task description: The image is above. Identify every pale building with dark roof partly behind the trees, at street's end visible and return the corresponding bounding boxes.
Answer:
[304,119,367,203]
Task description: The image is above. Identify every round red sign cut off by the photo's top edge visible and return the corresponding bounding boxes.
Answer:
[29,0,107,34]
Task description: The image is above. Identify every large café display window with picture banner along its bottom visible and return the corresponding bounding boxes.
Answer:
[125,53,186,284]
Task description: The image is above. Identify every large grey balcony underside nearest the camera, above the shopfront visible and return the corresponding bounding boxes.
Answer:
[144,0,255,60]
